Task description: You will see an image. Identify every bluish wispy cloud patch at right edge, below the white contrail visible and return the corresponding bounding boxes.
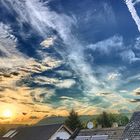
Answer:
[87,35,140,63]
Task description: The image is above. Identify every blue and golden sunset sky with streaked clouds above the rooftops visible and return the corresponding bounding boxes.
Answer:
[0,0,140,123]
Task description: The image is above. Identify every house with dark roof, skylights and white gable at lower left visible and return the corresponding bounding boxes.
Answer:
[3,124,72,140]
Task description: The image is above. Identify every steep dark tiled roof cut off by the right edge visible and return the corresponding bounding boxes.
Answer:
[123,112,140,140]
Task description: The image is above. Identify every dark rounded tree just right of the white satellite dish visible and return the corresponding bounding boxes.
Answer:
[97,112,113,128]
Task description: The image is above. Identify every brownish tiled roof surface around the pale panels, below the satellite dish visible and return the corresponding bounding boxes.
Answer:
[77,127,124,140]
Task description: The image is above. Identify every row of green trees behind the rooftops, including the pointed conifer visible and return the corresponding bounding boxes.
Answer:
[65,109,129,131]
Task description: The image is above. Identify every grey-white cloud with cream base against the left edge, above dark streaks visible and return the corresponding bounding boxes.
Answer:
[0,23,28,68]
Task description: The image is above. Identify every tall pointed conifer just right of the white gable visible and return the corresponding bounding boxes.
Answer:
[65,109,82,131]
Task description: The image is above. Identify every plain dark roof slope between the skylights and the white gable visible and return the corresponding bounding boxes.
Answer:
[4,124,66,140]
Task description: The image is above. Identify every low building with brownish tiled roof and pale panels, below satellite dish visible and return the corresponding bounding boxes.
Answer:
[75,127,124,140]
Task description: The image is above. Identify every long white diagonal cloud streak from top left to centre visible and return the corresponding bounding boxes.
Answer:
[1,0,99,94]
